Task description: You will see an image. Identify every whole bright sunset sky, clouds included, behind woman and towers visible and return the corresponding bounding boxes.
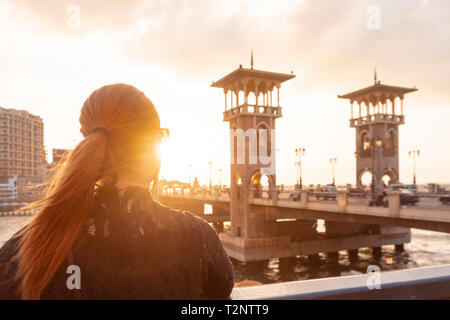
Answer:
[0,0,450,184]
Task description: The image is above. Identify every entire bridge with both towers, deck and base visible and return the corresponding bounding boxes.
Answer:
[158,59,450,262]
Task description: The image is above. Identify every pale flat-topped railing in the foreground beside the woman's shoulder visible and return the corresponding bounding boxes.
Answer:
[231,265,450,300]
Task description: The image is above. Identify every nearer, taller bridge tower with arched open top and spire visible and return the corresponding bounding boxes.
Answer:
[211,54,295,261]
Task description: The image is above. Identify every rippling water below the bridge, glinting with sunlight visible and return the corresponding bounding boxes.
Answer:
[0,217,450,283]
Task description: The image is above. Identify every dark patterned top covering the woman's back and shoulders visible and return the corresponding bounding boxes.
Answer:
[0,186,234,299]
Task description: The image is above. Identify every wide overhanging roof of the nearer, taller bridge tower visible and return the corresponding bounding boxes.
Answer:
[211,65,295,89]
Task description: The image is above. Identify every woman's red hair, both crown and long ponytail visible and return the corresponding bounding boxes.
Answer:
[15,84,160,299]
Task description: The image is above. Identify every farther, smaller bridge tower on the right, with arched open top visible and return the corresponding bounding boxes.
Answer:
[338,70,417,194]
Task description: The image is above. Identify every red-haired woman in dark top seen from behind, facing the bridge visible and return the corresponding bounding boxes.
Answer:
[0,84,234,299]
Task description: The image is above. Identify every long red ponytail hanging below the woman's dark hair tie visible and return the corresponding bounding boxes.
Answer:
[15,131,108,299]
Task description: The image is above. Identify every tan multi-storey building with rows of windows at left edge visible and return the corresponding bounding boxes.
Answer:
[0,107,46,201]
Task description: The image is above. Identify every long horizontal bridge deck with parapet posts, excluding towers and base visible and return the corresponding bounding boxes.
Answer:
[159,190,450,233]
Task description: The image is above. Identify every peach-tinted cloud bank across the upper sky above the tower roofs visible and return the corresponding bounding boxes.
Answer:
[5,0,450,103]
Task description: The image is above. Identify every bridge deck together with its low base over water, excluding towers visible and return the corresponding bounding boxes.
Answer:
[159,190,450,261]
